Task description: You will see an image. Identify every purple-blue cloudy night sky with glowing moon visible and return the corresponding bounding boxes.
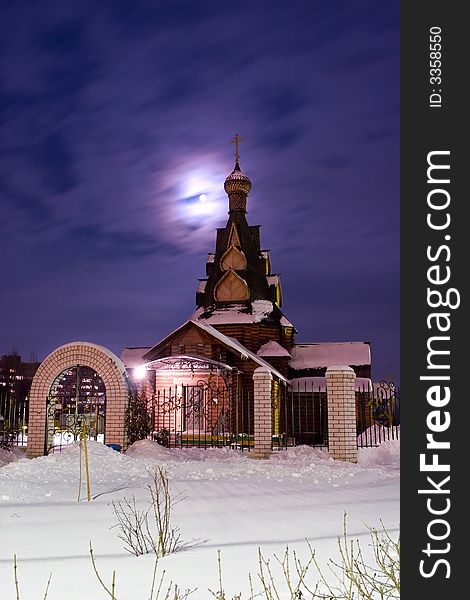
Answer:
[0,0,399,380]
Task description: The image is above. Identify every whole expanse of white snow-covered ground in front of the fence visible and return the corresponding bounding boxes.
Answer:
[0,441,399,600]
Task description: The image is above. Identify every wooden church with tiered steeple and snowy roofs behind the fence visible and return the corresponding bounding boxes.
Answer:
[121,141,371,445]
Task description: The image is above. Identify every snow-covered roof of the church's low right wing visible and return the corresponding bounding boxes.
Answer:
[289,342,370,369]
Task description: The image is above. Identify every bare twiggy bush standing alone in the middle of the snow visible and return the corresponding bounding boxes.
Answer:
[113,465,186,556]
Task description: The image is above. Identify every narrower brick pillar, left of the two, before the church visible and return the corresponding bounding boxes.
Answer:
[252,367,273,458]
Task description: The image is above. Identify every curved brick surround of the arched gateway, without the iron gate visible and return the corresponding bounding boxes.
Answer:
[27,342,129,458]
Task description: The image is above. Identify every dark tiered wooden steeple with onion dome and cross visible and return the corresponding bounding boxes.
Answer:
[191,134,295,358]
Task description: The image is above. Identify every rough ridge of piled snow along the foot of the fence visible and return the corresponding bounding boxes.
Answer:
[0,440,400,503]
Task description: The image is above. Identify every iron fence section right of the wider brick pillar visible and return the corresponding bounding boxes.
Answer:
[356,381,400,448]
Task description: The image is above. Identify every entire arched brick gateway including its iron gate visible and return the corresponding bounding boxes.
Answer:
[27,342,130,458]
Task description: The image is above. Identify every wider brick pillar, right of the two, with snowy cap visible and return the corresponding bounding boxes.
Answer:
[326,366,357,463]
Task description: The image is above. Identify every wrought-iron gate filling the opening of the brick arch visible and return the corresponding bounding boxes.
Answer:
[46,365,106,454]
